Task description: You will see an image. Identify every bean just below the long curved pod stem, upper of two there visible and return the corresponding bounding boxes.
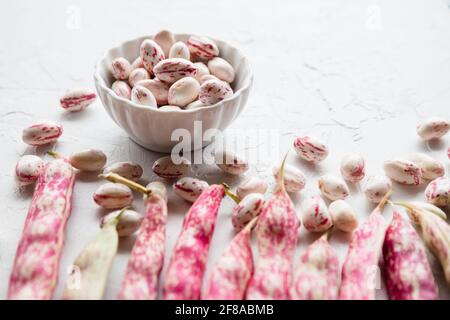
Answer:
[94,182,133,209]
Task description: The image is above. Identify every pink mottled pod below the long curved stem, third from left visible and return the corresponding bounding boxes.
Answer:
[119,194,167,300]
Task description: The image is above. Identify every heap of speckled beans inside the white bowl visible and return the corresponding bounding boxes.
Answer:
[111,30,235,110]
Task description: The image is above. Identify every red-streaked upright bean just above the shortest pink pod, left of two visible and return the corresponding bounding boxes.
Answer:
[300,195,333,232]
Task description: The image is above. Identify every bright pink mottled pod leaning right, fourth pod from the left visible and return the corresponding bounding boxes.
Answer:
[163,185,225,300]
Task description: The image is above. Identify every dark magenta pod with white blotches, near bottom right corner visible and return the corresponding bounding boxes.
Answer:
[383,211,438,300]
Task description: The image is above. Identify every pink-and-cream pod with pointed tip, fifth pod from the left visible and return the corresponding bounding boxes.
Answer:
[202,218,257,300]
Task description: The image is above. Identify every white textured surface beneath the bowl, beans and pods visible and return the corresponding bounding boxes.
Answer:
[0,0,450,299]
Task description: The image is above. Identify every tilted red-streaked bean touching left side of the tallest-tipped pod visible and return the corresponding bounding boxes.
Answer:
[231,193,265,232]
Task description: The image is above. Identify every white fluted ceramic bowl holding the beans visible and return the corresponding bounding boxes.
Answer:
[94,34,253,153]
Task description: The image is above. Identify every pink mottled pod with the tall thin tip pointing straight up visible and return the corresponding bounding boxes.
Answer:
[246,158,300,300]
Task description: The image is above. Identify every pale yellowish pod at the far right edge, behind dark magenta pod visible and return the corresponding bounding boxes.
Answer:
[398,202,450,284]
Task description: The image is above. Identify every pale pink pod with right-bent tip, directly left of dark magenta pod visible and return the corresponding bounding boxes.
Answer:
[339,192,391,300]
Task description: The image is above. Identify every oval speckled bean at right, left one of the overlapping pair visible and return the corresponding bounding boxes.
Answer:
[383,159,422,186]
